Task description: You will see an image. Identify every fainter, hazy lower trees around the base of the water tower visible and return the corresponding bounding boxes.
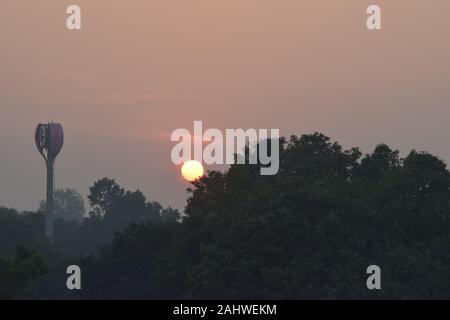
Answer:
[0,178,181,299]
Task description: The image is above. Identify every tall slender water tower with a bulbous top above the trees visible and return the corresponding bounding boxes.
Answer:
[34,122,64,239]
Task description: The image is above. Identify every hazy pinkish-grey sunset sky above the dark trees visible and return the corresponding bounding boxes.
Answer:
[0,0,450,210]
